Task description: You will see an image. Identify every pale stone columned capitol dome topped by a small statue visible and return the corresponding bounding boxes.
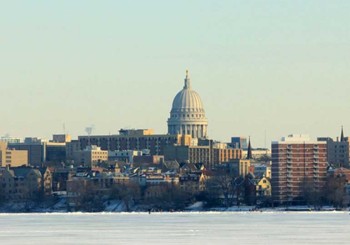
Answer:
[168,71,208,138]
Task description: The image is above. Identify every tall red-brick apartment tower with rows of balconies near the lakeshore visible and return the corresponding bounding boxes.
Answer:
[271,134,327,204]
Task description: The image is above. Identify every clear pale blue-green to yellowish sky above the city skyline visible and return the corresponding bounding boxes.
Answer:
[0,0,350,147]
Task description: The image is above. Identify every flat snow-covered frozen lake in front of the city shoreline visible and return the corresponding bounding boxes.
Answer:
[0,212,350,245]
